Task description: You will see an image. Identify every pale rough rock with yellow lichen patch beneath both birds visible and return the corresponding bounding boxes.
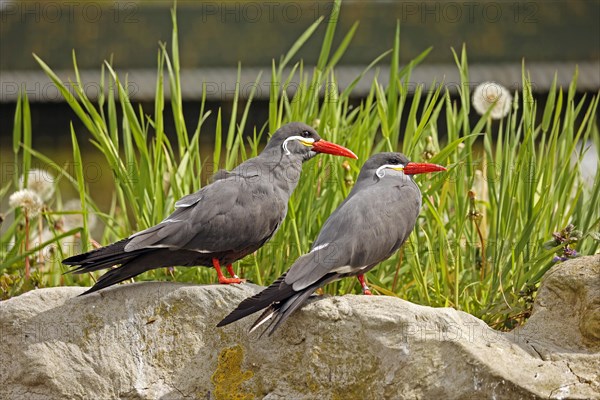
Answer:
[0,256,600,400]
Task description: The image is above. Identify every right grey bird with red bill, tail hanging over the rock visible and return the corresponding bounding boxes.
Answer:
[217,153,446,336]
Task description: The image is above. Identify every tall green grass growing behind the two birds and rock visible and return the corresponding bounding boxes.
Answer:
[0,3,600,329]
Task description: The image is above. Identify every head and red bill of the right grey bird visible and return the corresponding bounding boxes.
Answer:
[358,153,446,181]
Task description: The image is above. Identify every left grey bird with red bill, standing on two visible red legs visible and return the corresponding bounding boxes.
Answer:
[63,122,357,294]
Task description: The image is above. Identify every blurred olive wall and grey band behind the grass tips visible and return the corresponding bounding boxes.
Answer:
[0,0,600,203]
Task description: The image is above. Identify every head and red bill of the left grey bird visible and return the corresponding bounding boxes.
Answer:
[265,122,357,161]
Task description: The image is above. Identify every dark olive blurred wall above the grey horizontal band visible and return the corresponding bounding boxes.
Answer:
[0,0,600,71]
